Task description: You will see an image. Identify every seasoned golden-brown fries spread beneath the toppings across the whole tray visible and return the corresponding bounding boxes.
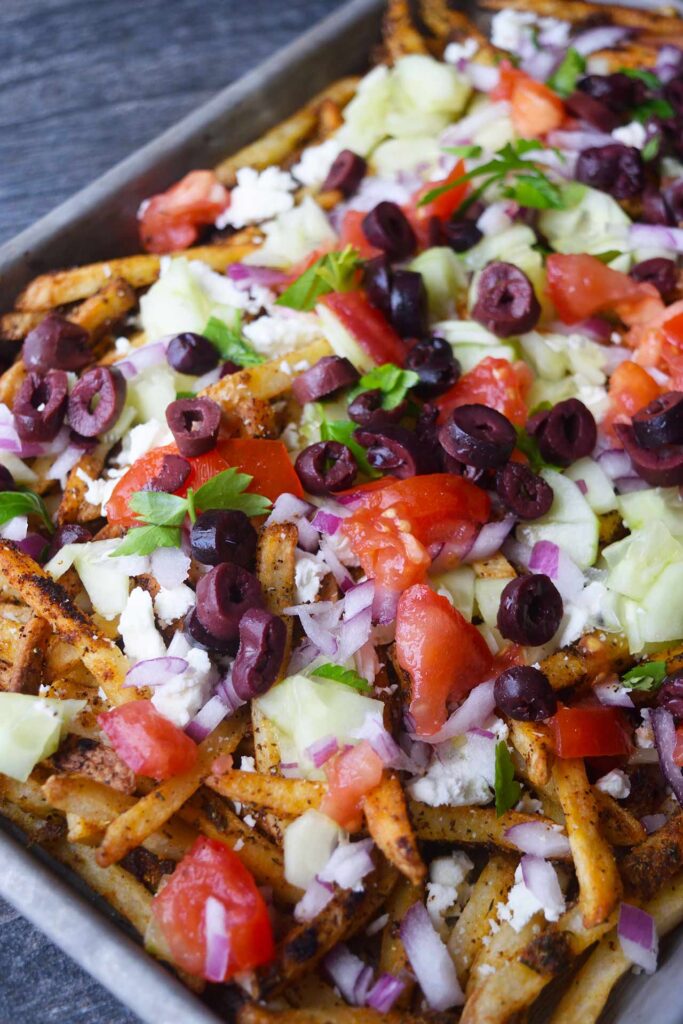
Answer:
[0,0,683,1024]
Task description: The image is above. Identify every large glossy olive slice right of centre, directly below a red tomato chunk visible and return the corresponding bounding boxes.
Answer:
[438,403,517,469]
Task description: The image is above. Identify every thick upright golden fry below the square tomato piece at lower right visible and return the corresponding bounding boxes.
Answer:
[553,758,622,928]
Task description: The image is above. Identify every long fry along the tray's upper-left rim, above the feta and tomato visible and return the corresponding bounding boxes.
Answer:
[215,78,359,186]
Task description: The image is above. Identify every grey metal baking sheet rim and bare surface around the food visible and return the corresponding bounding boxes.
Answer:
[0,0,683,1024]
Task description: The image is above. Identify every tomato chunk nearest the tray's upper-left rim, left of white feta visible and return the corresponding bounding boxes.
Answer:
[139,171,230,253]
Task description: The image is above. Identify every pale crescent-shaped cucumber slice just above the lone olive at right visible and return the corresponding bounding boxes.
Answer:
[517,469,599,569]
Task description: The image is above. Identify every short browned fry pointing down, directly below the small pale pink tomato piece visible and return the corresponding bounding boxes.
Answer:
[362,775,427,886]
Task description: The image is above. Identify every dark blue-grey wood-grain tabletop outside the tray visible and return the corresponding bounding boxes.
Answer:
[0,0,341,1024]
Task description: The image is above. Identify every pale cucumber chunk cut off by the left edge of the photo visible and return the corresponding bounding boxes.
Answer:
[0,692,86,782]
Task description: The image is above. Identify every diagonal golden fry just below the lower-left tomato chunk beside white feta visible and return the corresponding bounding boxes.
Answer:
[97,714,246,867]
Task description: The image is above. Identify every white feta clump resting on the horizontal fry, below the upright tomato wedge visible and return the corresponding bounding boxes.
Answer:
[409,733,496,807]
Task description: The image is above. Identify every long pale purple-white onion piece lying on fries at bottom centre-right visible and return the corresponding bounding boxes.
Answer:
[400,903,465,1011]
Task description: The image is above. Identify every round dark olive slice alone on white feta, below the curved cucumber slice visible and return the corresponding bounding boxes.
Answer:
[498,573,564,647]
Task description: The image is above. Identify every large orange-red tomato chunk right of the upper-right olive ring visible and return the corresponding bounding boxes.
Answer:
[546,253,663,324]
